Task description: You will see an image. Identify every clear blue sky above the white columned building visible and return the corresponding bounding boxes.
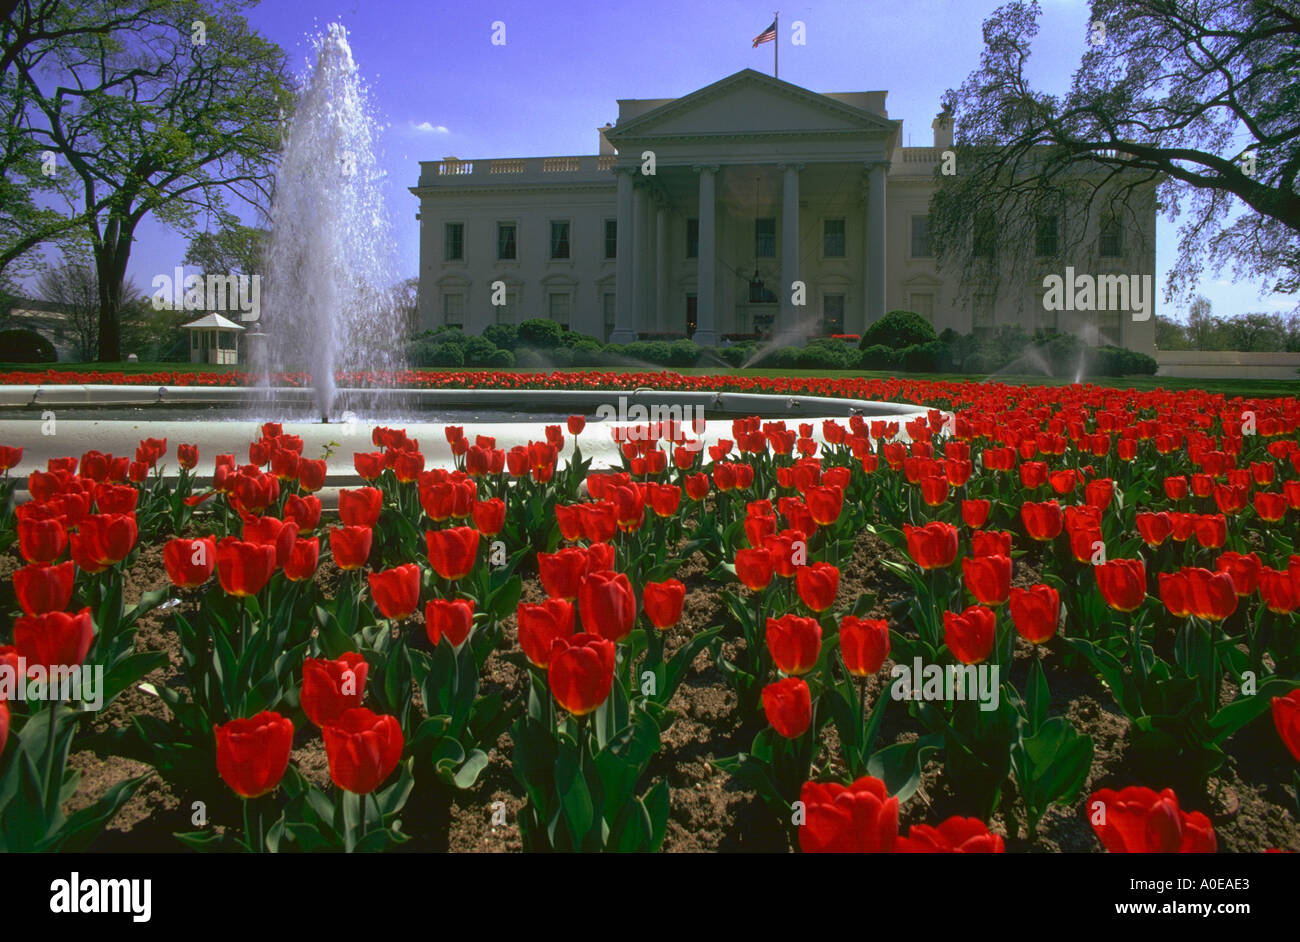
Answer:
[101,0,1294,316]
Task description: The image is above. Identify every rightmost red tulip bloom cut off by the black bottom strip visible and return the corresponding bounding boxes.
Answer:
[1086,786,1218,854]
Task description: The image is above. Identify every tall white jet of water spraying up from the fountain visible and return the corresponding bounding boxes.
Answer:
[260,23,402,422]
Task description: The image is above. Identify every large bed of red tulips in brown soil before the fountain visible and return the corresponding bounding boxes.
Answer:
[0,373,1300,852]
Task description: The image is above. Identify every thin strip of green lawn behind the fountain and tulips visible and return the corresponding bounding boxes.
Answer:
[0,363,1300,396]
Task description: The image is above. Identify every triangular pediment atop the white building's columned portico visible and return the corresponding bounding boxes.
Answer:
[606,69,894,143]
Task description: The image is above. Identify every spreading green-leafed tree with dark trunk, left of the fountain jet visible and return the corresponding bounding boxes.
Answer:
[0,0,291,360]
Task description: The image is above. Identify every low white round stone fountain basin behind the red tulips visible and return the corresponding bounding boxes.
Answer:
[0,385,928,500]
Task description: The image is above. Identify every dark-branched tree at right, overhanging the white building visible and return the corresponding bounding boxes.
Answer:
[931,0,1300,309]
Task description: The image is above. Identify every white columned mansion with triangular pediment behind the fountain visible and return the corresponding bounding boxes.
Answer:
[411,69,1156,351]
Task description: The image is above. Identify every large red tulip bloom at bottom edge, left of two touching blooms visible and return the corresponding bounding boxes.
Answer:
[800,776,898,854]
